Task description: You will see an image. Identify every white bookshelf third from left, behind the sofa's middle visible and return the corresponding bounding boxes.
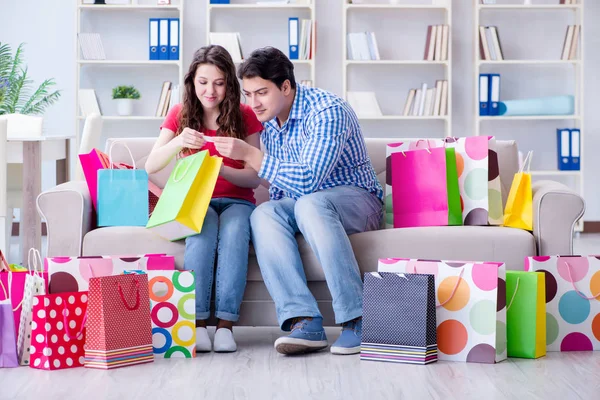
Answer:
[342,0,452,136]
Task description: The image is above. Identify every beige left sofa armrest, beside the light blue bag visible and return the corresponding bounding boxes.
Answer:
[37,181,94,257]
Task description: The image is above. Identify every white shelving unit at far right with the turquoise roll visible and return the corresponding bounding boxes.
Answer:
[473,0,585,231]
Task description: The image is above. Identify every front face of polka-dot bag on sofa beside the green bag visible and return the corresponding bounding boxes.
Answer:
[446,136,489,225]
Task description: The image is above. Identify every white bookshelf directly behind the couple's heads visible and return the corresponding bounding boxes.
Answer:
[206,0,317,85]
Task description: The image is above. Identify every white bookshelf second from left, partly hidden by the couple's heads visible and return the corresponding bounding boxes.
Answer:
[205,0,316,86]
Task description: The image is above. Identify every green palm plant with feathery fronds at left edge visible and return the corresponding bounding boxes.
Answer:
[0,42,60,115]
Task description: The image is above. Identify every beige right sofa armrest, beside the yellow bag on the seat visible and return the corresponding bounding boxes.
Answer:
[532,181,585,256]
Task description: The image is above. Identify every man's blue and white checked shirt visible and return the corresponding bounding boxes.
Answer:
[258,84,383,200]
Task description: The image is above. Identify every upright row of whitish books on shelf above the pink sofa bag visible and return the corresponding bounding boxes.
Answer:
[402,80,448,117]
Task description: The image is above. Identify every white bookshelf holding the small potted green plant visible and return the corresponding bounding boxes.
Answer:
[75,0,184,158]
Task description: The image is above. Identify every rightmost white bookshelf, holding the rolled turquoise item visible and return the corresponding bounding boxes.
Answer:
[473,0,586,231]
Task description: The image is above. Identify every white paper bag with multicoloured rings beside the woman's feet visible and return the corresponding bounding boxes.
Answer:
[125,271,196,358]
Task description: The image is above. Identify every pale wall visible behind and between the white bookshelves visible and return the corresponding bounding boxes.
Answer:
[0,0,600,220]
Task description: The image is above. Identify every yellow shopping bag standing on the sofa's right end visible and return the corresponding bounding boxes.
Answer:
[504,151,533,231]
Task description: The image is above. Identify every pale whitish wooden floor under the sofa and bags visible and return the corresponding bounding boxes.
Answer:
[0,235,600,400]
